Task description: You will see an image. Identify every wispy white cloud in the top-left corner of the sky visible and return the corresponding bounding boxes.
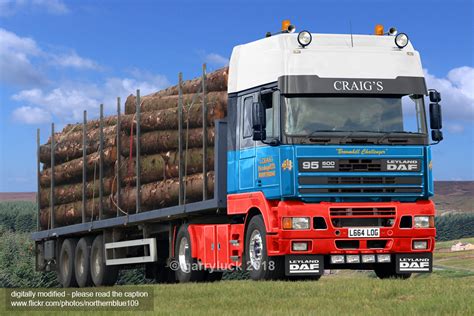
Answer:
[0,0,70,16]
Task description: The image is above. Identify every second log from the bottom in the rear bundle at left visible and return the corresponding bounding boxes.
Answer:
[40,178,116,208]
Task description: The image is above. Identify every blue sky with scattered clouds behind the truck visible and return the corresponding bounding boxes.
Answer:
[0,0,474,192]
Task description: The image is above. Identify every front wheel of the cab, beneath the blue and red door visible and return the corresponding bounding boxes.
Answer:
[242,215,285,280]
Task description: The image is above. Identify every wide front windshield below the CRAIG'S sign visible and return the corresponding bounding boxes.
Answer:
[283,96,426,136]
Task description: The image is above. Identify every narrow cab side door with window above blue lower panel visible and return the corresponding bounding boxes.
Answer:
[238,93,257,192]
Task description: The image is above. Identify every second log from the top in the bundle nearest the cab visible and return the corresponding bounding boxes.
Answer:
[125,91,227,114]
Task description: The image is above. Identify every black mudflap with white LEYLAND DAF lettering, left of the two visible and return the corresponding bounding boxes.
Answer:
[285,255,324,276]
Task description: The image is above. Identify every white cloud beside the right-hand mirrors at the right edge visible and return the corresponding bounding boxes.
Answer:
[425,66,474,122]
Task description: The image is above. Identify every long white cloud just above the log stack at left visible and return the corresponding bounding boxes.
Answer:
[12,69,169,124]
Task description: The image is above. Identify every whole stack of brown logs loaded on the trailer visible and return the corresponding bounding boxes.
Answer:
[39,68,228,229]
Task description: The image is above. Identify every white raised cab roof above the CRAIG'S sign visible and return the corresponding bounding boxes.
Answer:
[228,33,424,93]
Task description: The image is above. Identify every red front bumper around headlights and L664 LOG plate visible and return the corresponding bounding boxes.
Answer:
[267,201,436,256]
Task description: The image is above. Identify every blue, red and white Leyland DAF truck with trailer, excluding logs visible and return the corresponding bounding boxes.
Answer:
[32,20,443,287]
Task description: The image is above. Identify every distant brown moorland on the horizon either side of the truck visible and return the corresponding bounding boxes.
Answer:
[0,181,474,214]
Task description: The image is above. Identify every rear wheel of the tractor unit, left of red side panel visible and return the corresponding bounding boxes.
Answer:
[174,224,206,283]
